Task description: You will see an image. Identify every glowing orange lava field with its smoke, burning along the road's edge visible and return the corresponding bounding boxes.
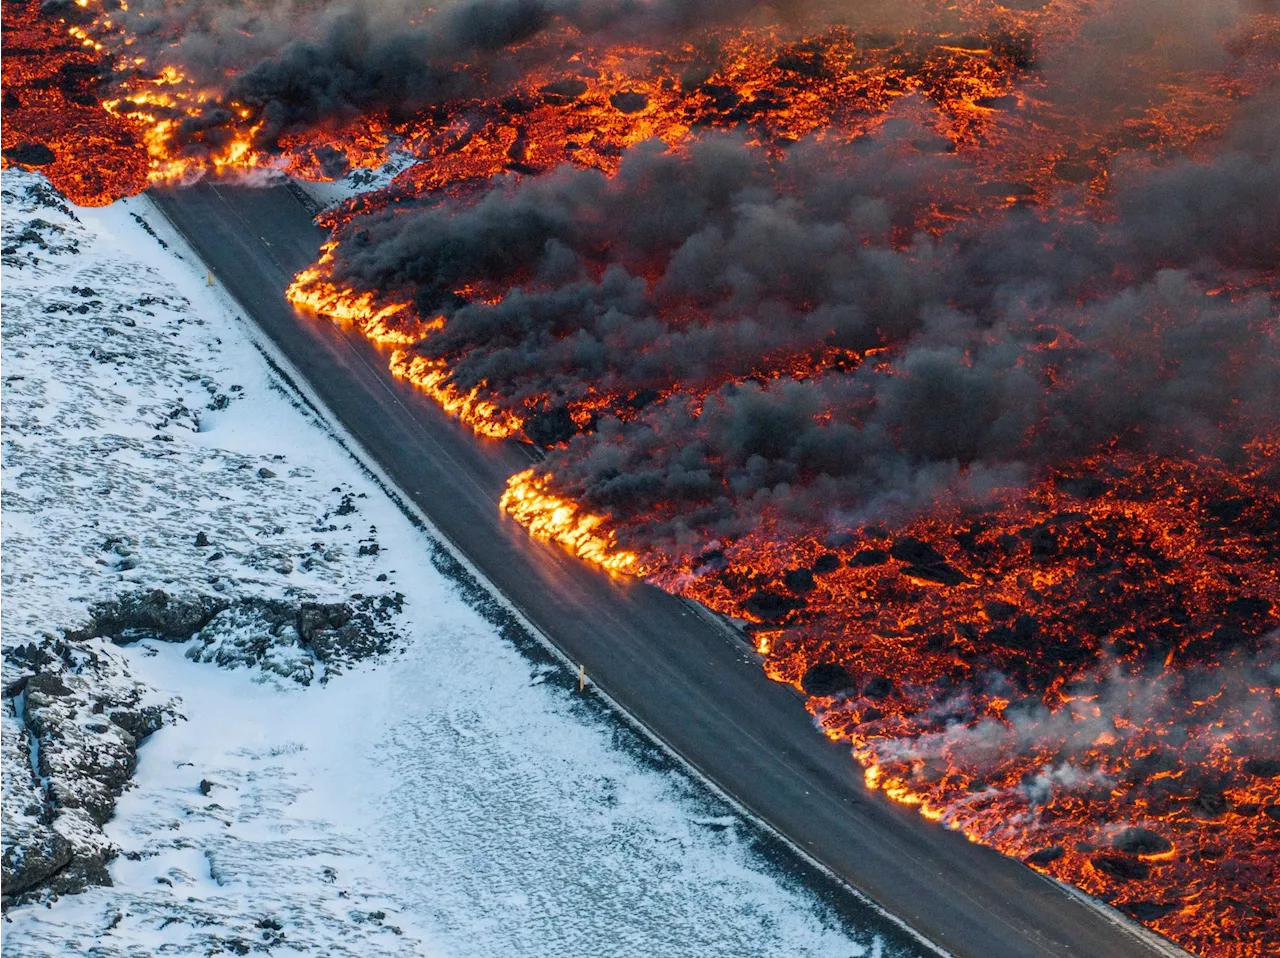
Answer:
[0,0,1280,958]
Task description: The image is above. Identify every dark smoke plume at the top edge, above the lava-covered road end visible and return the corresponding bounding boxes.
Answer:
[94,0,829,149]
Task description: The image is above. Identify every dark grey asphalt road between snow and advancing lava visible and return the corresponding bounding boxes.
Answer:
[152,184,1177,958]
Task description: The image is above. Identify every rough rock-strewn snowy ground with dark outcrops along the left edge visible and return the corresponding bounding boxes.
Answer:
[0,172,403,908]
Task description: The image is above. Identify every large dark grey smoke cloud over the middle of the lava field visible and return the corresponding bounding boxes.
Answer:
[325,101,1280,548]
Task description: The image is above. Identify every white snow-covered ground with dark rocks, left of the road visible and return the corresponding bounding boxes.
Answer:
[0,170,911,958]
